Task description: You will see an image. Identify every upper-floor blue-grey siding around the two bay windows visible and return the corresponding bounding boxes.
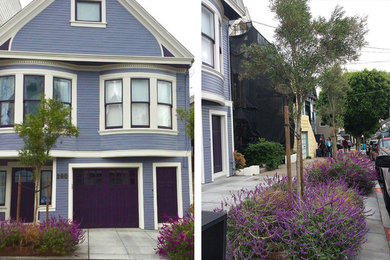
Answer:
[0,65,190,151]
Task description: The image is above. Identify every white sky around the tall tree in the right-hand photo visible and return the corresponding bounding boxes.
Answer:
[244,0,390,72]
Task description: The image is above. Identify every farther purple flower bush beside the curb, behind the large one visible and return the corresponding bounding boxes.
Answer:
[305,151,378,195]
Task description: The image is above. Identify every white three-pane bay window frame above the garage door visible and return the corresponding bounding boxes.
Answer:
[99,72,178,135]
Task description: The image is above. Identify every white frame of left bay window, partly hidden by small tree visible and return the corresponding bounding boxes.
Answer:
[0,69,77,134]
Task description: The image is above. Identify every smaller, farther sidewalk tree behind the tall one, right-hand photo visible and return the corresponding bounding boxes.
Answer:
[316,64,349,158]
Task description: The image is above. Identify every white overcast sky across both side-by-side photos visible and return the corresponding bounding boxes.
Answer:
[21,0,390,72]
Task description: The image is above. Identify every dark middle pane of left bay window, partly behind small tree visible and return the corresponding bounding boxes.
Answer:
[23,75,45,120]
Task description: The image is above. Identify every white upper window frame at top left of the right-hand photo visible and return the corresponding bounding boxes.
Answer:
[201,0,224,74]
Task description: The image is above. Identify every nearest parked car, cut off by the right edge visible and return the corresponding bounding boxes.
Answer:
[375,137,390,212]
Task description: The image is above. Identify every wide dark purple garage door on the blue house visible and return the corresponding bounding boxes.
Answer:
[73,168,139,228]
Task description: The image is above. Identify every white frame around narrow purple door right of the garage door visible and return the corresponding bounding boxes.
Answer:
[153,162,183,229]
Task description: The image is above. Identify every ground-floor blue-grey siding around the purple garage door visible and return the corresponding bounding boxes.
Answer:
[38,157,190,229]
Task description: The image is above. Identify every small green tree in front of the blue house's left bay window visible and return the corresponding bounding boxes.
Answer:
[15,98,79,223]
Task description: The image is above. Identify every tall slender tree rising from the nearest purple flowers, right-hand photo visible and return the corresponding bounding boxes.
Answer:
[243,0,367,194]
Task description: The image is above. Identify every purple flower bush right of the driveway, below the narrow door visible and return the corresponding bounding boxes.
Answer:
[155,214,194,260]
